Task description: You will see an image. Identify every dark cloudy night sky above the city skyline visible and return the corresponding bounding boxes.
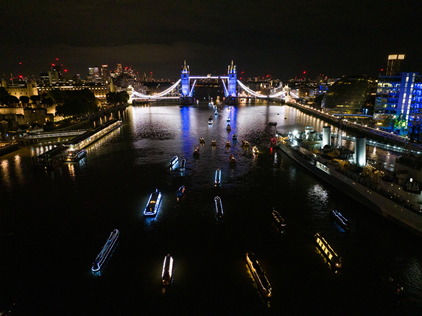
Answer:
[0,0,422,78]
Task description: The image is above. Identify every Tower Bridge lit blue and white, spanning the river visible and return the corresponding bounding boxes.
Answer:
[130,61,297,105]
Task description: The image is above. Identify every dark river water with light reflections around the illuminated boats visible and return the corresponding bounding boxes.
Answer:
[0,95,422,315]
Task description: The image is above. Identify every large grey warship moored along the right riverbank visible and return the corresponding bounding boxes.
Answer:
[276,129,422,236]
